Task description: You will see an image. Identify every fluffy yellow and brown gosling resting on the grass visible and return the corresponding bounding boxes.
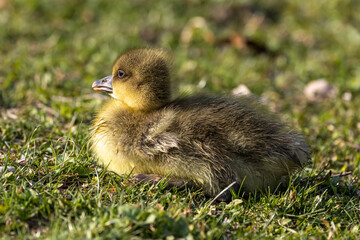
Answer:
[90,48,310,201]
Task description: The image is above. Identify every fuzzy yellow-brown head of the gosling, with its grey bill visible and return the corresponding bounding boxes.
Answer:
[92,48,171,111]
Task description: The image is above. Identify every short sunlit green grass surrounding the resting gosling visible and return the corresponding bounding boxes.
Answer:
[0,0,360,239]
